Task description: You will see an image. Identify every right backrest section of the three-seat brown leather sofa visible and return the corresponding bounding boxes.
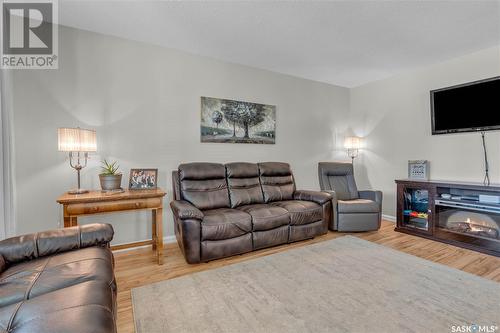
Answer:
[258,162,295,202]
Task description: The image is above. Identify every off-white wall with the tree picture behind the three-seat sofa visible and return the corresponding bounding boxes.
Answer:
[8,27,349,244]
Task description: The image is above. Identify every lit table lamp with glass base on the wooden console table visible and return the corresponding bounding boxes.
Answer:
[57,127,97,194]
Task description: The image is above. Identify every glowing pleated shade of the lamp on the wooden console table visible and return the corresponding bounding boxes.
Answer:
[57,128,97,152]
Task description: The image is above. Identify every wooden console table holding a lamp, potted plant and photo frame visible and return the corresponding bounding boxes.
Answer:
[57,189,165,265]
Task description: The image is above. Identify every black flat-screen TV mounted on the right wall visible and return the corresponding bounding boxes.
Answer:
[431,76,500,134]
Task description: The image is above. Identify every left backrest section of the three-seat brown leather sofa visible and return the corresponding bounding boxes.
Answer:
[178,163,230,209]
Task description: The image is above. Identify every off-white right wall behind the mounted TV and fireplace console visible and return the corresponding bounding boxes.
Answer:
[350,47,500,216]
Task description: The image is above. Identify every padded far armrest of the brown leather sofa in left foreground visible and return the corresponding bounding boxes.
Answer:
[0,223,114,265]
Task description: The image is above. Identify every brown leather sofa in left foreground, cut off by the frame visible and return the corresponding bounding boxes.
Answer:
[0,224,116,333]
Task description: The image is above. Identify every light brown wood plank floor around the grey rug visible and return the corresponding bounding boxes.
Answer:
[115,221,500,333]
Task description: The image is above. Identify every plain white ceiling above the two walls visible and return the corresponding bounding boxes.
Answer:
[59,0,500,87]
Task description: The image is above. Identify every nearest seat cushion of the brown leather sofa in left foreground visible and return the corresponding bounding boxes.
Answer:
[0,280,116,333]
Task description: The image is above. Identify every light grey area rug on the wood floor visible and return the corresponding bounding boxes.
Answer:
[132,236,500,333]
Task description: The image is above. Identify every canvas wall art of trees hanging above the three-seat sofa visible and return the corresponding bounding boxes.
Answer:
[201,97,276,144]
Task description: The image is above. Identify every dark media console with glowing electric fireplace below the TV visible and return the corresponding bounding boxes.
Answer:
[395,180,500,257]
